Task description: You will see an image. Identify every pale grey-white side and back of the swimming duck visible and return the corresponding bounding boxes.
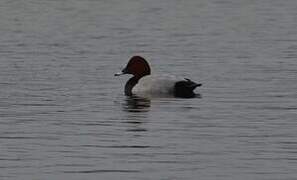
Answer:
[132,75,184,95]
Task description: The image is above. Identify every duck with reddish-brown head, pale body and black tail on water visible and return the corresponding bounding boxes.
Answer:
[114,56,202,98]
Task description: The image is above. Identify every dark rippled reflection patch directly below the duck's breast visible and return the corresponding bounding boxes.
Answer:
[124,95,151,112]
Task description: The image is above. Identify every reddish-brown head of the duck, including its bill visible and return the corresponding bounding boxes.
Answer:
[115,56,151,78]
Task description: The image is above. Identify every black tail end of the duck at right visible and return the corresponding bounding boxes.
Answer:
[174,78,202,98]
